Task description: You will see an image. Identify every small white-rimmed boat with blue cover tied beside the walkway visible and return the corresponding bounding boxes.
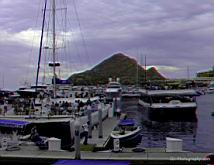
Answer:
[110,119,141,147]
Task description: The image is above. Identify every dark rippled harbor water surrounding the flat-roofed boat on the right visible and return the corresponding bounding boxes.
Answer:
[122,94,214,152]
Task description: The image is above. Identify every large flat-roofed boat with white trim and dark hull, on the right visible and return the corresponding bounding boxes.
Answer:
[139,89,198,121]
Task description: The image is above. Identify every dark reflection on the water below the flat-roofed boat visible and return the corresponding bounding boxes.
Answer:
[142,122,197,148]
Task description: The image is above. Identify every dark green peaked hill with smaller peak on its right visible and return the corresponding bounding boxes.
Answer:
[69,53,165,85]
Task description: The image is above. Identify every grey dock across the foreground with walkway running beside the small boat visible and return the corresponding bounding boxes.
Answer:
[0,113,209,165]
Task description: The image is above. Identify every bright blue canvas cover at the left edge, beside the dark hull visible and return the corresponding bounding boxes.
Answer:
[0,119,30,128]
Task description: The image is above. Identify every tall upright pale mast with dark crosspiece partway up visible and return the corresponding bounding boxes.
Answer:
[52,0,56,98]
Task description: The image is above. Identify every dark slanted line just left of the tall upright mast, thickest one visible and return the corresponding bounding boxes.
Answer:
[36,0,47,91]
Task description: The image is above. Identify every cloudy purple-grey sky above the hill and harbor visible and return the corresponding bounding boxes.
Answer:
[0,0,214,88]
